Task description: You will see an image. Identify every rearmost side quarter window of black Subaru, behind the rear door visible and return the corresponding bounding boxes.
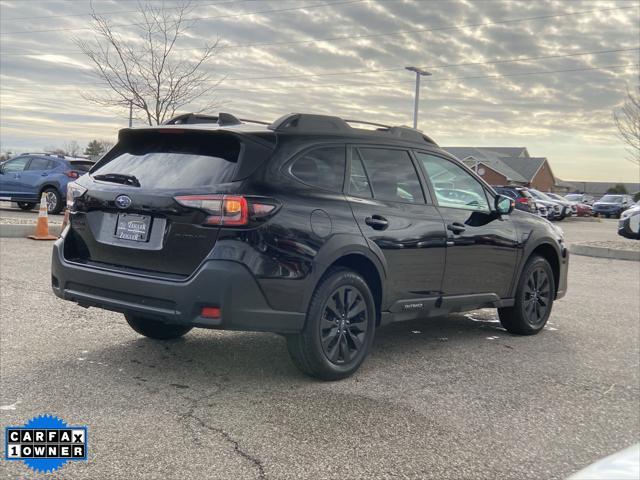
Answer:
[291,147,346,192]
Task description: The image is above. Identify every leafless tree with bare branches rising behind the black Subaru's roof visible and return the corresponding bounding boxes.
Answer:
[76,1,222,125]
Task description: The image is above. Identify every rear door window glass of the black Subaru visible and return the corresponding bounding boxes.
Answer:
[359,148,425,203]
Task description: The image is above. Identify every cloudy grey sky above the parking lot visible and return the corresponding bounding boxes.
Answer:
[0,0,640,181]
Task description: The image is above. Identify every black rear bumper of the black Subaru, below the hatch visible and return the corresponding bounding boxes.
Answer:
[51,239,305,333]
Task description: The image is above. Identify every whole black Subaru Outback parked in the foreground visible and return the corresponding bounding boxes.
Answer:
[51,114,569,379]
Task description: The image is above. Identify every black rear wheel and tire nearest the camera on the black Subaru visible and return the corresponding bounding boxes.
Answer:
[287,268,376,380]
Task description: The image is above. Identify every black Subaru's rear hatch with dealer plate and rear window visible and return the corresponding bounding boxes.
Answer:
[64,127,272,277]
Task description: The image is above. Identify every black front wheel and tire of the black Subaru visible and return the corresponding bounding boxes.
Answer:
[498,255,556,335]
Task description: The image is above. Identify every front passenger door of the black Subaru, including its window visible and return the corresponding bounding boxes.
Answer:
[416,152,517,298]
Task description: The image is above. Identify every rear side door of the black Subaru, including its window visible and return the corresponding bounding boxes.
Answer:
[347,146,446,302]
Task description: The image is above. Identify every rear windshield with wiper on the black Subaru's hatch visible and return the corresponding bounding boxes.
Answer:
[91,131,240,188]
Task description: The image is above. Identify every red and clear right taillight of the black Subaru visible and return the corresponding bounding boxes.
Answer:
[175,195,276,227]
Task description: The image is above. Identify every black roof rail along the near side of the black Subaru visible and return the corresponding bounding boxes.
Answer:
[268,113,436,145]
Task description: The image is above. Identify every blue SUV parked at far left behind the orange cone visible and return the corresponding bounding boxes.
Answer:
[0,153,94,213]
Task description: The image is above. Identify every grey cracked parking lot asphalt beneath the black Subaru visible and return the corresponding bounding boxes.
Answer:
[0,235,640,480]
